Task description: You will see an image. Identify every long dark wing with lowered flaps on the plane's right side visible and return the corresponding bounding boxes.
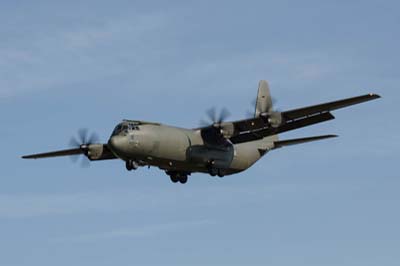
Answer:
[230,94,380,144]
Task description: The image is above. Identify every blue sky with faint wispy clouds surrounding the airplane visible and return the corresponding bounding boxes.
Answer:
[0,1,400,266]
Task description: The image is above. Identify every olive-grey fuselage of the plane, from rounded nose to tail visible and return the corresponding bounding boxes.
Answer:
[108,122,277,175]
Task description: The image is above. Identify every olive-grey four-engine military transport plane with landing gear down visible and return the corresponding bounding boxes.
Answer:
[22,80,380,184]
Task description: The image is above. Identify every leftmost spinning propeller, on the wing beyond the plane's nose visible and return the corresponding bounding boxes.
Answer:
[69,128,99,167]
